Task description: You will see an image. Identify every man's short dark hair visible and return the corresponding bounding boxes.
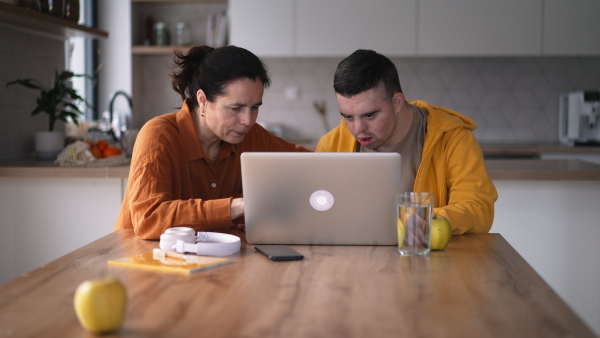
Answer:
[333,49,402,100]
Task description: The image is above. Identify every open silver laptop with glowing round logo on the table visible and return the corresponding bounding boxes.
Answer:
[241,152,401,245]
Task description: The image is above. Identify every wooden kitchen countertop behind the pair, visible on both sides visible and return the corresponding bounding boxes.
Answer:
[0,159,600,181]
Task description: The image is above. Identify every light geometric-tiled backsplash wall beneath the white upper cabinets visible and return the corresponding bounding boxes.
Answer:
[134,57,600,143]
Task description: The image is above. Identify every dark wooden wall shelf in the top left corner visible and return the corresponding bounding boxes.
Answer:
[0,2,108,40]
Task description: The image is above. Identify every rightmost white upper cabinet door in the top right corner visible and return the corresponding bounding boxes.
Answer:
[543,0,600,56]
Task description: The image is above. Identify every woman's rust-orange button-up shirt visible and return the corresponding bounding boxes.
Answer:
[114,103,308,239]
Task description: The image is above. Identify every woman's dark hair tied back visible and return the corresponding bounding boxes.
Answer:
[171,46,271,110]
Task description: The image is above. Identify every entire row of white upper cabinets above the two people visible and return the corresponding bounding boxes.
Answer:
[229,0,600,57]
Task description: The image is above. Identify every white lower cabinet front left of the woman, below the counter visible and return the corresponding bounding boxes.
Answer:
[0,177,127,284]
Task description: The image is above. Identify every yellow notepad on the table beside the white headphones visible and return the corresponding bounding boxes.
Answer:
[108,252,232,275]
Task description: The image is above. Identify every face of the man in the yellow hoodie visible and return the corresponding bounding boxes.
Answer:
[336,84,404,150]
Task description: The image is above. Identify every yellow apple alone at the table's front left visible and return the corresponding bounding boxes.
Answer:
[73,278,127,333]
